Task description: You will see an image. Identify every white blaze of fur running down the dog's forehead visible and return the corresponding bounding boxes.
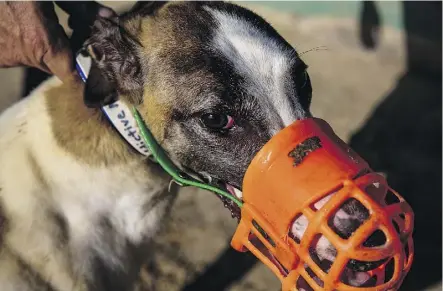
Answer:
[206,7,302,131]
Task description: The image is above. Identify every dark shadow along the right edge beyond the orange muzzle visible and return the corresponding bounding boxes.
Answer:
[350,2,442,291]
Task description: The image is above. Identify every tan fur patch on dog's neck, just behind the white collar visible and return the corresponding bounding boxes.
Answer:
[46,79,146,165]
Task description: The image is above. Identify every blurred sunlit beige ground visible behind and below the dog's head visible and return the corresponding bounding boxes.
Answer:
[0,2,441,291]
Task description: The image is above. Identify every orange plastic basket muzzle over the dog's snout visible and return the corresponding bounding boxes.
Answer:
[231,118,414,291]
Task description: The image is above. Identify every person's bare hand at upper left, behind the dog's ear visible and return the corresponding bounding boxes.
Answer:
[0,1,74,80]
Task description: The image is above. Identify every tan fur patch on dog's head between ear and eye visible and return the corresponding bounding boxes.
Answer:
[133,2,221,142]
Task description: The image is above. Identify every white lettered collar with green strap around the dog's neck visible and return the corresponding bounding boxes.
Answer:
[75,53,243,208]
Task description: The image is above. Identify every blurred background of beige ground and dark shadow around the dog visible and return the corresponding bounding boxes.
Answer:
[0,1,442,291]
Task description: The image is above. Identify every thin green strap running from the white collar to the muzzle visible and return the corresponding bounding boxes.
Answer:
[132,107,243,208]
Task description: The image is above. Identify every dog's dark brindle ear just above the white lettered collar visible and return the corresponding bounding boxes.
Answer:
[84,17,143,108]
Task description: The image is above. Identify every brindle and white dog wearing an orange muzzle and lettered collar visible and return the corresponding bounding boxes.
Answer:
[0,1,384,291]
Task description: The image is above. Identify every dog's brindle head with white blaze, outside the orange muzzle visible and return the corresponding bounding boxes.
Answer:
[85,2,386,285]
